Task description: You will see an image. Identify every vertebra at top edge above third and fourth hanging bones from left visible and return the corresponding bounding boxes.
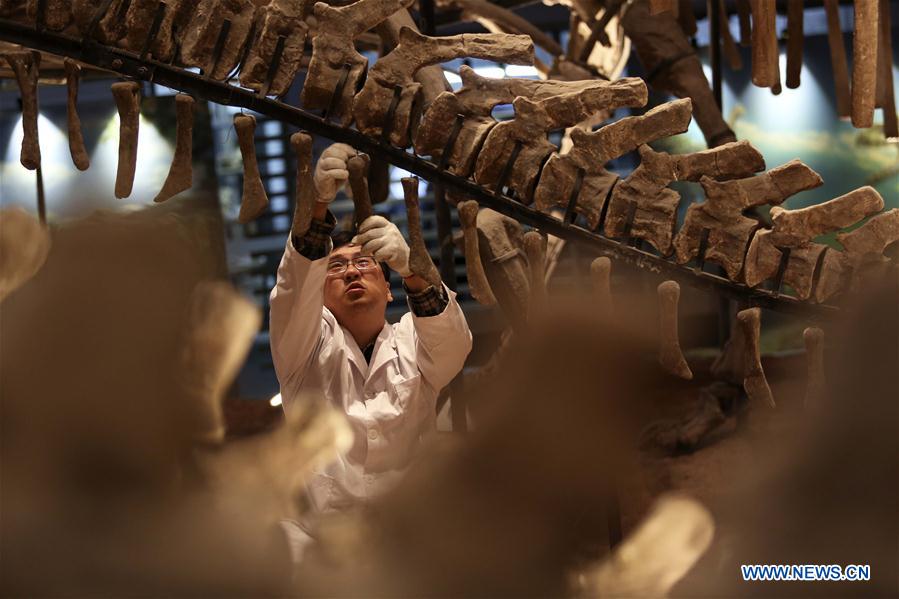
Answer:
[122,0,198,62]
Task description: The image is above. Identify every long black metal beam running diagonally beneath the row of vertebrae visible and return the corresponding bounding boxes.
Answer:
[0,19,838,321]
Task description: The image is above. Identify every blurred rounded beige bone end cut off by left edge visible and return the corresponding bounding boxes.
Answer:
[0,208,50,302]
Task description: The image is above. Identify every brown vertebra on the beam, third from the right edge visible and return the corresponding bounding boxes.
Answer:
[674,160,822,281]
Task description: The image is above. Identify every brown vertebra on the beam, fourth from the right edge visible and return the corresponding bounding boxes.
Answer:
[604,141,765,255]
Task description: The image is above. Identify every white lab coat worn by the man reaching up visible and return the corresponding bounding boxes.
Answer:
[269,240,471,530]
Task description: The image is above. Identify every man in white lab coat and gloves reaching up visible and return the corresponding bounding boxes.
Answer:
[270,144,471,558]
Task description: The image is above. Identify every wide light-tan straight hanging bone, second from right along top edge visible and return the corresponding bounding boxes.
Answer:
[852,0,879,129]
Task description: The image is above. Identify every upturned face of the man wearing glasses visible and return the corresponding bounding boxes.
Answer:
[324,244,393,323]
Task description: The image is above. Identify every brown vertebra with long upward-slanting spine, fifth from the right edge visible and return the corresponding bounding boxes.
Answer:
[534,98,692,229]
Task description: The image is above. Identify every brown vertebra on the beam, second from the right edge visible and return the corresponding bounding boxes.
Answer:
[743,187,883,302]
